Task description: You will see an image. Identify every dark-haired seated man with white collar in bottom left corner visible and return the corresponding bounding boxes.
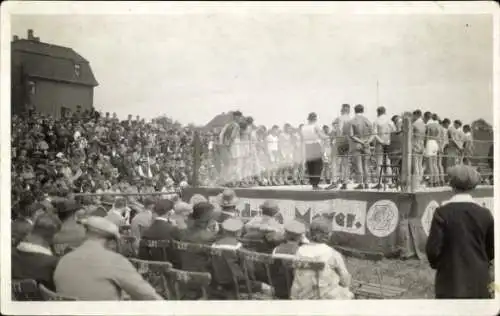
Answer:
[11,214,61,290]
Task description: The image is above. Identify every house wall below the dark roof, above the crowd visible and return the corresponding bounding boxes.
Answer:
[28,79,94,118]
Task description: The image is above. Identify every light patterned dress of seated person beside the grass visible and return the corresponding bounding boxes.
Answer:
[291,243,354,300]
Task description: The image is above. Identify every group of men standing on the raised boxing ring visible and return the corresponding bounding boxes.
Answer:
[217,104,484,189]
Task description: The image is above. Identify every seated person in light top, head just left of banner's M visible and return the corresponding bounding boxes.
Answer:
[243,200,284,253]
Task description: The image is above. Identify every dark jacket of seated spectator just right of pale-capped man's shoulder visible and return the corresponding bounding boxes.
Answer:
[138,218,180,266]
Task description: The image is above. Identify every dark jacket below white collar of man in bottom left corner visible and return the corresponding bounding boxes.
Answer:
[11,249,59,291]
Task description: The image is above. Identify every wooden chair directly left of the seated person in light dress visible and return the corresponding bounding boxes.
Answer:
[238,249,274,300]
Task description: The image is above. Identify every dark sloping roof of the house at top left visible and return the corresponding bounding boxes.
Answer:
[12,39,99,87]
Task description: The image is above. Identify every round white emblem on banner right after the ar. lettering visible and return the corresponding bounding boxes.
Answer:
[366,200,399,237]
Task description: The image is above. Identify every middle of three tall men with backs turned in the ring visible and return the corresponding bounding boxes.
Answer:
[349,104,373,190]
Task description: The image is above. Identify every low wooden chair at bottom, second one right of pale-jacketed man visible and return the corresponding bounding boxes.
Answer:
[166,268,212,300]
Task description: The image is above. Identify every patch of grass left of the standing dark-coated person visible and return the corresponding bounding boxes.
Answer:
[344,256,434,299]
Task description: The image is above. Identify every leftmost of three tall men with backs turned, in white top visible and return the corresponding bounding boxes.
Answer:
[327,104,351,190]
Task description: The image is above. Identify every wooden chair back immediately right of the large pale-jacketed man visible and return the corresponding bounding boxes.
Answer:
[129,258,172,299]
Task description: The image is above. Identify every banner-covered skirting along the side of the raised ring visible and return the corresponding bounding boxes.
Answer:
[183,187,493,258]
